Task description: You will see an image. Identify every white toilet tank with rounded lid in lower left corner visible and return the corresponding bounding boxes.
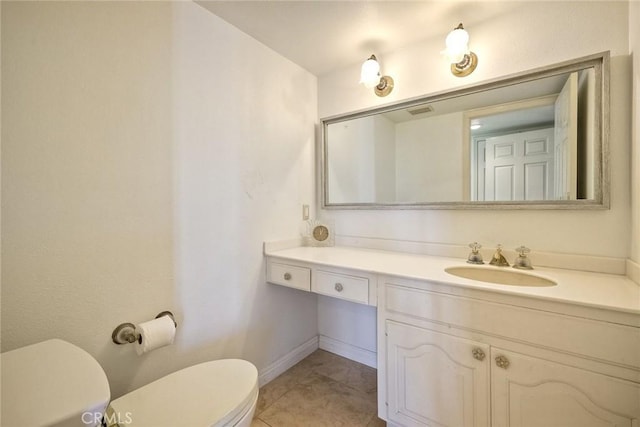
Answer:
[0,339,110,427]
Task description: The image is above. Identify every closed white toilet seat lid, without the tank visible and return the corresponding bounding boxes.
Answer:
[109,359,258,427]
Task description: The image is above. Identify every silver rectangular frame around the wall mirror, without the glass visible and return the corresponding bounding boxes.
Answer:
[320,51,610,210]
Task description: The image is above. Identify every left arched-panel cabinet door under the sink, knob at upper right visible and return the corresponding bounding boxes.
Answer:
[386,321,489,427]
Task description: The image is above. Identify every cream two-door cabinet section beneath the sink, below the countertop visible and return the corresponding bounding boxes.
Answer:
[378,277,640,427]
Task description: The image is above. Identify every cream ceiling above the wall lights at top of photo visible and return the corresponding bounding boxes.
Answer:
[196,0,508,76]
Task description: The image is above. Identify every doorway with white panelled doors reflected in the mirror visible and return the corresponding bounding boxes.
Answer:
[468,72,586,202]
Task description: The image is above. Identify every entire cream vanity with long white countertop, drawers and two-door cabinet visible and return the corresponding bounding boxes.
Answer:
[265,247,640,427]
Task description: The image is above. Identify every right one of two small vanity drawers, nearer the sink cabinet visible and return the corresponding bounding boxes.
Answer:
[312,270,369,304]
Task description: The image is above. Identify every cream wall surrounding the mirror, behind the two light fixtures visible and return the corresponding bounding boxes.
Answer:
[318,1,640,360]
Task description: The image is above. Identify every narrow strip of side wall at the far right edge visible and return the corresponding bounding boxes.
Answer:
[629,1,640,266]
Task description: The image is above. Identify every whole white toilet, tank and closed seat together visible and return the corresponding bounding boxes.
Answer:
[0,339,258,427]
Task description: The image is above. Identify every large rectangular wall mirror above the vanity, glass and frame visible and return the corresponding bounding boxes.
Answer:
[322,52,609,209]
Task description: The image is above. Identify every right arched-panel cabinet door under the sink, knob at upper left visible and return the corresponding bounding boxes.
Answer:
[491,347,640,427]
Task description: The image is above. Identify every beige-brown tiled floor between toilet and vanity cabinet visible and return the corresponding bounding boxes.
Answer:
[251,350,386,427]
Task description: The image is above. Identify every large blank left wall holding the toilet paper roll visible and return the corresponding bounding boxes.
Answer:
[2,2,317,397]
